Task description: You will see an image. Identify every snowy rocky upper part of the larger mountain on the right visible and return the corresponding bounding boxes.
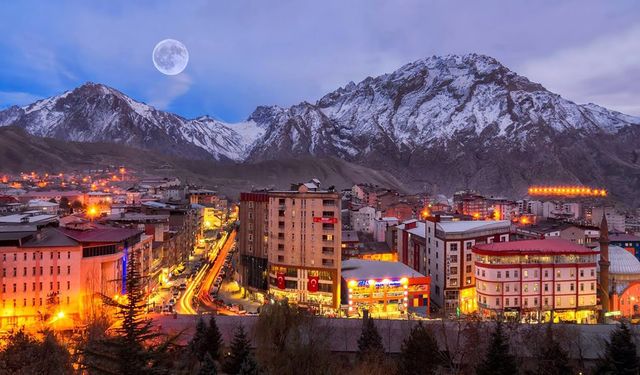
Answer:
[250,54,640,160]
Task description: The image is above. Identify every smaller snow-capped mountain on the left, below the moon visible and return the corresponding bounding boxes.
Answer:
[0,83,263,161]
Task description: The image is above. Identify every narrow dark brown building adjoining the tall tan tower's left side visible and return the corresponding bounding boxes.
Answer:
[238,192,269,292]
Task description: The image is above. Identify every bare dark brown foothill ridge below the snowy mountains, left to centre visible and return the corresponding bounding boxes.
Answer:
[0,126,403,198]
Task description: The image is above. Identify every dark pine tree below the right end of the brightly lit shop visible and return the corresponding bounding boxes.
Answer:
[398,322,442,375]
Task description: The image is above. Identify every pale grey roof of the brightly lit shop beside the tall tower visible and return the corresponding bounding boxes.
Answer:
[341,259,424,280]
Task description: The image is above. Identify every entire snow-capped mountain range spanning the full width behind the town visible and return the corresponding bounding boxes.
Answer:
[0,54,640,205]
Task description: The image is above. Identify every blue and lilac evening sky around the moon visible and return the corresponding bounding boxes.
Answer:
[0,0,640,121]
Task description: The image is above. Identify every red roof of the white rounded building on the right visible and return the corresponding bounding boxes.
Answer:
[473,239,597,255]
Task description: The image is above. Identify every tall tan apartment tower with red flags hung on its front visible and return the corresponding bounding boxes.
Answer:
[268,181,342,308]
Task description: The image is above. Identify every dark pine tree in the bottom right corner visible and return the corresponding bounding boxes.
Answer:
[597,321,640,375]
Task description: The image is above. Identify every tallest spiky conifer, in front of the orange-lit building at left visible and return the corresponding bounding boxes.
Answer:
[83,247,168,375]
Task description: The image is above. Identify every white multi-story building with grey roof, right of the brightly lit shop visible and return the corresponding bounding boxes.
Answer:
[420,216,511,314]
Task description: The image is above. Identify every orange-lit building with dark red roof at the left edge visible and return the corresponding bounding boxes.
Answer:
[0,226,146,329]
